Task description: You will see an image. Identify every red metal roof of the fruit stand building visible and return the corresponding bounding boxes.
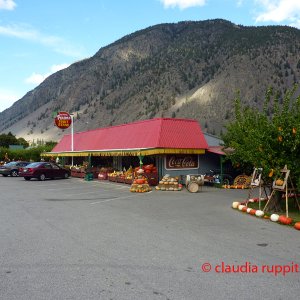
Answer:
[52,118,208,153]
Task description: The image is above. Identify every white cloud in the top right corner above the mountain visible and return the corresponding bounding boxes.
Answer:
[256,0,300,25]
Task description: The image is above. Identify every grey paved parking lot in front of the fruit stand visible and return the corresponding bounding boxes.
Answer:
[0,177,300,300]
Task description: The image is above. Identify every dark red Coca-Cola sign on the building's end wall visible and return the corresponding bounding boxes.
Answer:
[166,154,199,170]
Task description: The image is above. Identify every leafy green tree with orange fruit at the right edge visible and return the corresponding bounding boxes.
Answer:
[222,86,300,213]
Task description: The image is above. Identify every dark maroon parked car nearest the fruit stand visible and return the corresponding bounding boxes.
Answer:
[20,162,70,180]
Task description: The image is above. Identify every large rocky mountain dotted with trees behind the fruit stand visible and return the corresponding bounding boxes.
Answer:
[0,20,300,140]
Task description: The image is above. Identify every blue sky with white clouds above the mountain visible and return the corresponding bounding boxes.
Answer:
[0,0,300,112]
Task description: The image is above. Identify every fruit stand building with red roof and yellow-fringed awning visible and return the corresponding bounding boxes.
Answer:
[43,118,225,177]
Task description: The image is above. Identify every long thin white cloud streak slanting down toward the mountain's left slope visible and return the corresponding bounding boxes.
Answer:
[0,23,82,58]
